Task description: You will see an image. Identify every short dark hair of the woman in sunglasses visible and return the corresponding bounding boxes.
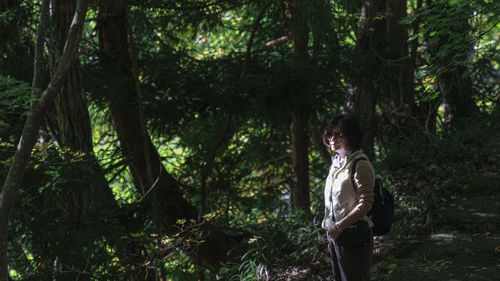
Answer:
[323,114,363,151]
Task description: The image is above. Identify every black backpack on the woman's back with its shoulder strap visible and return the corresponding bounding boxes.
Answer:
[351,157,394,236]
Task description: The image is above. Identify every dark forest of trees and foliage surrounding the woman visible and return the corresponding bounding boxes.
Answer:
[0,0,500,281]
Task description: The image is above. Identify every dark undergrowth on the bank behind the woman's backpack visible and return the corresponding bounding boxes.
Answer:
[378,114,491,238]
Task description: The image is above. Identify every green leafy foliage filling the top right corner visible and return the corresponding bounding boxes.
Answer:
[403,0,500,114]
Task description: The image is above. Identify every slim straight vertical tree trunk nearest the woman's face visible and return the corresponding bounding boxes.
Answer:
[289,0,311,212]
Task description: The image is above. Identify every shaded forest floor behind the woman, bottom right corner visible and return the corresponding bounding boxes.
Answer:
[372,123,500,281]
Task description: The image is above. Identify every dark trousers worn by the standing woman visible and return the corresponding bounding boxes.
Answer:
[326,230,373,281]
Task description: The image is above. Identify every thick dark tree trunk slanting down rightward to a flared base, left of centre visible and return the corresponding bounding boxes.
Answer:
[99,1,197,230]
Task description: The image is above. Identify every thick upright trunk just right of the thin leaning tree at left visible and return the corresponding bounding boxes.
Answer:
[38,0,124,279]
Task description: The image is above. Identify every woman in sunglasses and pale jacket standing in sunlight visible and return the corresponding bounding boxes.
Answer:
[322,115,375,281]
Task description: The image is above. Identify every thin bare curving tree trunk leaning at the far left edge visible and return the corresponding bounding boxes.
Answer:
[0,0,88,281]
